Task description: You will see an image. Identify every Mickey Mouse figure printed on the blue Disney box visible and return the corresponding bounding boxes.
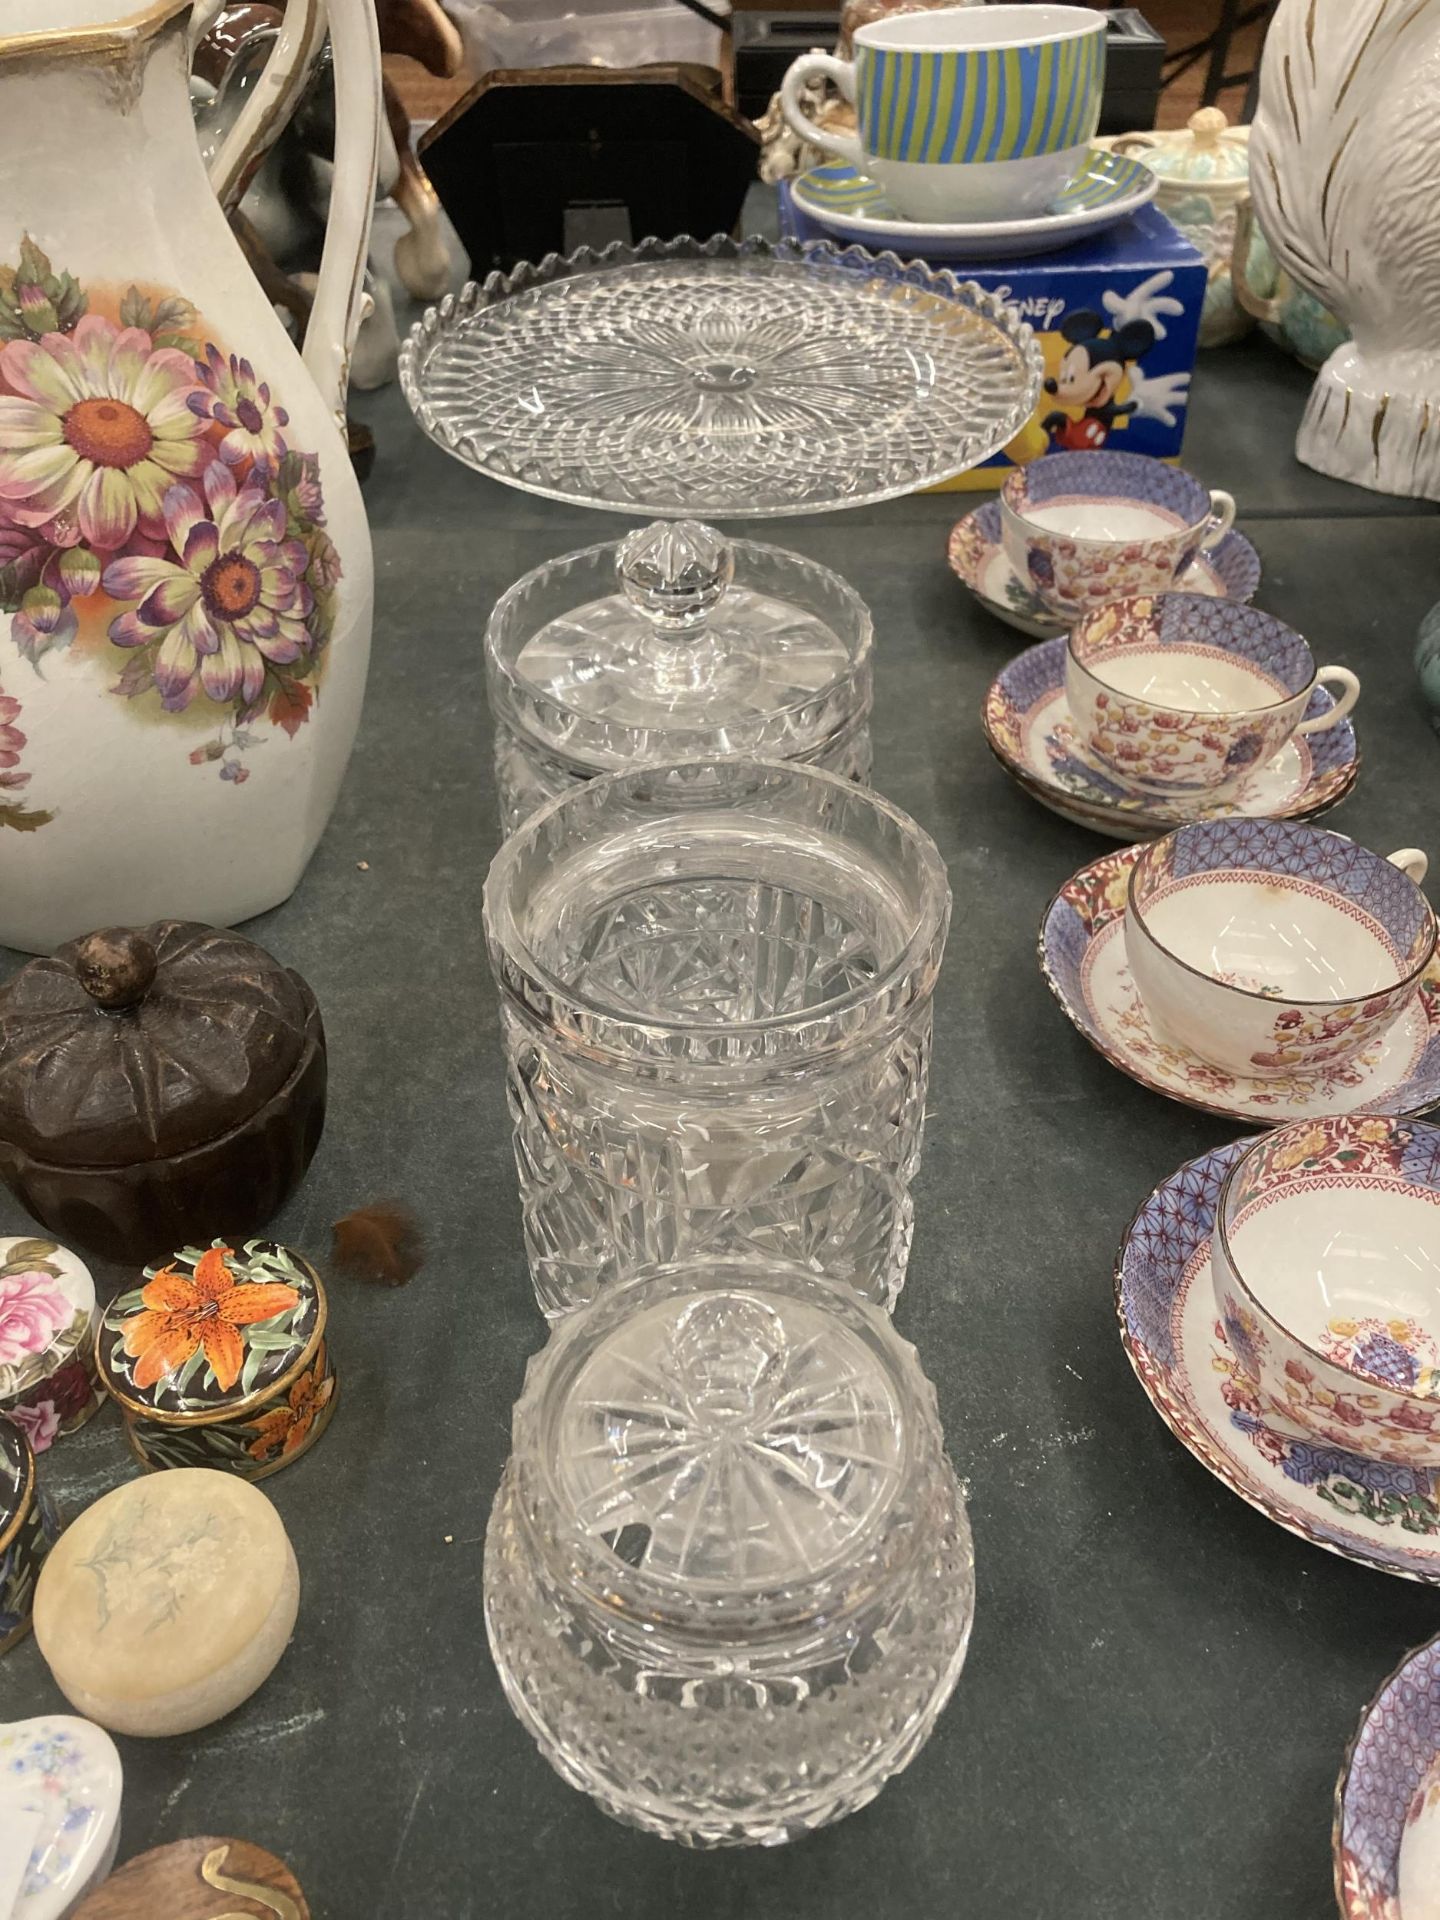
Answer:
[1041,271,1190,453]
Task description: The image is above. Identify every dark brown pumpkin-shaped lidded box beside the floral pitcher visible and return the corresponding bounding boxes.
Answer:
[0,920,326,1261]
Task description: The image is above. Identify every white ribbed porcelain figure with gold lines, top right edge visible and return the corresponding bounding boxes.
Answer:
[1250,0,1440,499]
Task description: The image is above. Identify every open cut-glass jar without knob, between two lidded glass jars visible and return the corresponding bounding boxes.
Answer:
[486,760,950,1315]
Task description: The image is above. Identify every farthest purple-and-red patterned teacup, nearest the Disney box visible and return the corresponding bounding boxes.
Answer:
[1000,453,1235,618]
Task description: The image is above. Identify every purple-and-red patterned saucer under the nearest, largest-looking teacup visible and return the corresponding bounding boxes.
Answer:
[1116,1129,1440,1582]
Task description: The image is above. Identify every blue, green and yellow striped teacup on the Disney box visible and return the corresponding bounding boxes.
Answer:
[781,6,1106,223]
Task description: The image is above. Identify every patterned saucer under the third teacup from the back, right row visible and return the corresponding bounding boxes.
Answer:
[1041,844,1440,1127]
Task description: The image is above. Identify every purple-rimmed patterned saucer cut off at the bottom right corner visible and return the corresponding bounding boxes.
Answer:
[1334,1640,1440,1920]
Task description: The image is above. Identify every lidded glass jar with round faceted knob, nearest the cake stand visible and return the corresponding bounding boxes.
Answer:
[486,520,872,833]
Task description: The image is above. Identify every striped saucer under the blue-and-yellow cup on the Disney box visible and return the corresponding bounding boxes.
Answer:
[791,148,1160,259]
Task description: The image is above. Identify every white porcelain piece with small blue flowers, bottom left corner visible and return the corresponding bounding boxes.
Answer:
[0,1713,121,1920]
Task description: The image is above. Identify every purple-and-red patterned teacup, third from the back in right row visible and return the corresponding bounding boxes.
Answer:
[1125,818,1436,1079]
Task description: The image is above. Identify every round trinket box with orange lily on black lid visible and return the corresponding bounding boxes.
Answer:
[96,1240,336,1480]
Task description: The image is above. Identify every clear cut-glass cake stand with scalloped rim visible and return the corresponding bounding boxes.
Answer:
[399,236,1041,520]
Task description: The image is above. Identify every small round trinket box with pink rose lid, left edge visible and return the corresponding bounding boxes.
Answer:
[0,1236,100,1453]
